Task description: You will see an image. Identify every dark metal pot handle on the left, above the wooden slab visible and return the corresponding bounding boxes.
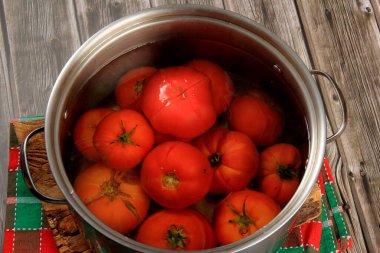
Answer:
[20,127,68,204]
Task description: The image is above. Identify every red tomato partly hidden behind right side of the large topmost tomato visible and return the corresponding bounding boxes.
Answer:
[186,59,234,114]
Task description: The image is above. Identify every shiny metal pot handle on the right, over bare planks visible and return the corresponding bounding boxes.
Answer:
[310,69,347,142]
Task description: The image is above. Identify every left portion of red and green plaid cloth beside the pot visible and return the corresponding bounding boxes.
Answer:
[3,119,58,253]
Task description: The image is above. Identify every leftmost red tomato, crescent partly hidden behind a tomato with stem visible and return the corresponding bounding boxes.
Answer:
[73,108,113,161]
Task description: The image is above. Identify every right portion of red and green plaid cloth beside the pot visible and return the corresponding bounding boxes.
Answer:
[277,158,352,253]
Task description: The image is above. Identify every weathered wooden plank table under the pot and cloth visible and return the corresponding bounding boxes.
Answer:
[0,0,380,252]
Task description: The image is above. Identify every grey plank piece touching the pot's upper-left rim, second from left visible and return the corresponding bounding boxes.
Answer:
[74,0,150,43]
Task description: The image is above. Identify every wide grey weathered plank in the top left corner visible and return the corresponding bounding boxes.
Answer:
[3,0,79,116]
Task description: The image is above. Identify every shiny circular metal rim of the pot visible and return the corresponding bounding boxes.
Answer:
[45,5,326,253]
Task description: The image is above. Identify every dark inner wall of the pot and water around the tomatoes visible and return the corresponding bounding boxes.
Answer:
[60,20,309,180]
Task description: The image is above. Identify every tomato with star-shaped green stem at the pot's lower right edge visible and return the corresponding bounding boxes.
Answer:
[214,190,281,245]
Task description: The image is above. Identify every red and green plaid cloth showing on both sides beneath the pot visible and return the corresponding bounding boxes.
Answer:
[3,117,352,253]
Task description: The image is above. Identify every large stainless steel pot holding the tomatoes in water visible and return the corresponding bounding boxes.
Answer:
[20,5,346,253]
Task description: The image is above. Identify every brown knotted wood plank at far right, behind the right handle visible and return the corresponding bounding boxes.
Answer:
[297,0,380,252]
